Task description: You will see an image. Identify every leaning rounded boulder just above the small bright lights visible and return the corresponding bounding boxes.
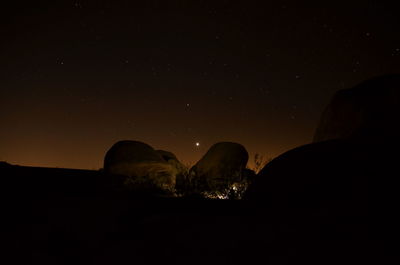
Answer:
[189,142,249,191]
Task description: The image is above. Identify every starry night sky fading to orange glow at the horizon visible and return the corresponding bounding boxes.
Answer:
[0,0,400,169]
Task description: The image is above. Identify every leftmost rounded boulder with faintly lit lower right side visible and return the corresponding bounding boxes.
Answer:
[104,141,179,192]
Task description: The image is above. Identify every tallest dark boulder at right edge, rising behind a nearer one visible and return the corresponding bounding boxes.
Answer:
[314,75,400,142]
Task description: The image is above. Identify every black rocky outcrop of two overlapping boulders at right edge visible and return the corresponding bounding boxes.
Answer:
[245,75,400,215]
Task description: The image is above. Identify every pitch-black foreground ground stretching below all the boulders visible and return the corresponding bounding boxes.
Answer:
[0,161,399,264]
